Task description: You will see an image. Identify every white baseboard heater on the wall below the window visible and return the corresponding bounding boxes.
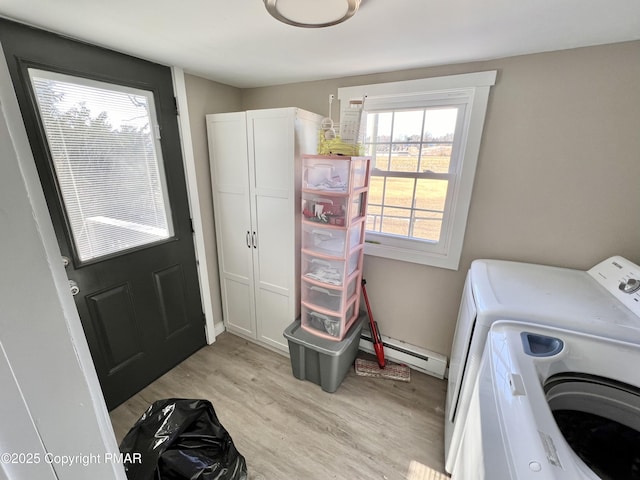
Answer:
[360,329,447,378]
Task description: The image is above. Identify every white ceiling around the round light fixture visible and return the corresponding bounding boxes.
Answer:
[0,0,640,88]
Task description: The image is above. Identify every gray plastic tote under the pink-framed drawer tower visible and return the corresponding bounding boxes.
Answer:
[284,313,366,393]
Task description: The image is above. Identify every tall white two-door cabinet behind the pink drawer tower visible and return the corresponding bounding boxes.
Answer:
[207,108,322,352]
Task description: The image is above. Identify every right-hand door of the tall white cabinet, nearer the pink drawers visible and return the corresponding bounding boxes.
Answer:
[247,109,299,351]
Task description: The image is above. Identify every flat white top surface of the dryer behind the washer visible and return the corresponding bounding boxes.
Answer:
[470,260,640,342]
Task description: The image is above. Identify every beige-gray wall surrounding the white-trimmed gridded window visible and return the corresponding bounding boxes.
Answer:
[189,42,640,356]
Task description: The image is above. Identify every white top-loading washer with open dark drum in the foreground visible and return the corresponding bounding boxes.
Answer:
[451,321,640,480]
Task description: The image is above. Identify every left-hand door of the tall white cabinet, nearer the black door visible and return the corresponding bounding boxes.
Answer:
[207,112,256,338]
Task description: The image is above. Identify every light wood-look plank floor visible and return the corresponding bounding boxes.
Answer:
[111,333,448,480]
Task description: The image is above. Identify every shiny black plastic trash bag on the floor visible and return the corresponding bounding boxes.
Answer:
[120,398,247,480]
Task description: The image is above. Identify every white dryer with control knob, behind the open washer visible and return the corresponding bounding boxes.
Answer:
[444,256,640,473]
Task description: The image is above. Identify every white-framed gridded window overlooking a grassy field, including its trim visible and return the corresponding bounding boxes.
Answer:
[338,71,496,270]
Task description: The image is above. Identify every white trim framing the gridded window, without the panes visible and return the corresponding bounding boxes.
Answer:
[338,70,497,270]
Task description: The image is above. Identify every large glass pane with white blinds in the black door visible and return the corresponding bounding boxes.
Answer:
[29,69,173,261]
